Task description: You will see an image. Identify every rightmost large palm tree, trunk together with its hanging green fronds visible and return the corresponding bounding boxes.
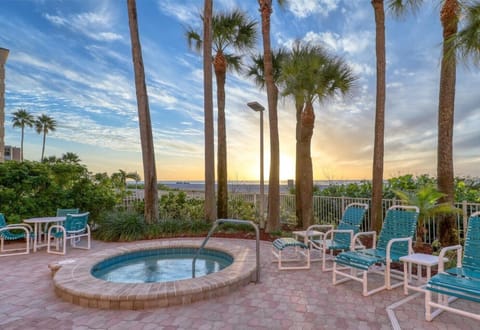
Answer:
[389,0,480,246]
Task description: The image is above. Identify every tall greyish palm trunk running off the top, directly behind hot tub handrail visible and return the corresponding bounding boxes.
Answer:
[203,0,217,222]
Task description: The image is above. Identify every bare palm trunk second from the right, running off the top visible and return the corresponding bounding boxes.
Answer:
[371,0,386,232]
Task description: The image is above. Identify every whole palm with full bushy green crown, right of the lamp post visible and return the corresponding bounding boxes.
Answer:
[280,42,356,228]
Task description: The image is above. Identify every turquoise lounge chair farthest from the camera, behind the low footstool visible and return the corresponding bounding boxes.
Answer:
[306,203,368,272]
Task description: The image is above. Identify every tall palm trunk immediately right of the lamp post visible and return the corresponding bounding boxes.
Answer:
[258,0,286,233]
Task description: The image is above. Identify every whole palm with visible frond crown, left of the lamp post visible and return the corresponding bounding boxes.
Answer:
[187,10,257,218]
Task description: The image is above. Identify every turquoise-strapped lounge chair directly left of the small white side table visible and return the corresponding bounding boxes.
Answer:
[332,205,419,296]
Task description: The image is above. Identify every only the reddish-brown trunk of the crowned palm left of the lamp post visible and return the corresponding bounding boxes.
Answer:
[213,51,228,219]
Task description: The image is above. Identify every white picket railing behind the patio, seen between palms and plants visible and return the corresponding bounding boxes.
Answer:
[121,191,480,243]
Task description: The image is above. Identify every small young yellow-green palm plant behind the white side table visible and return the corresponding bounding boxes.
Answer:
[395,184,461,245]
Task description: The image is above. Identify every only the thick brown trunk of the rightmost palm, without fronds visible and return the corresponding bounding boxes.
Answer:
[437,0,460,246]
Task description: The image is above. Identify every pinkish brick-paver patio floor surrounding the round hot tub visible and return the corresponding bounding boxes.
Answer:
[0,240,480,330]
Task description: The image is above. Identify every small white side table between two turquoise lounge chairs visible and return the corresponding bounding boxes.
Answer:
[400,253,448,295]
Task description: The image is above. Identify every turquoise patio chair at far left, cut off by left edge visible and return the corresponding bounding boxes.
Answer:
[0,213,33,257]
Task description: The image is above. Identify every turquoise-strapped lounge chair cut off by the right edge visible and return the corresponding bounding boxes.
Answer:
[425,212,480,321]
